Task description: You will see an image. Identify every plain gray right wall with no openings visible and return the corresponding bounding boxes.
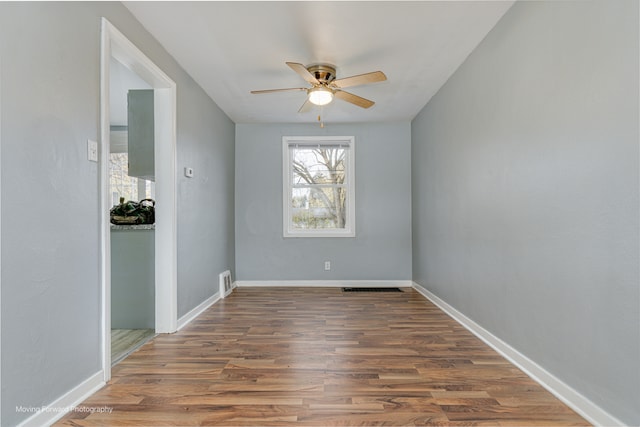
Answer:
[412,0,640,425]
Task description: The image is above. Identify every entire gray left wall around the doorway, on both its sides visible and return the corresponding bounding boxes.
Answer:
[0,2,235,426]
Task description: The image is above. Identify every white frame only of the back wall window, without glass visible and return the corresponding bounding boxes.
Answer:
[282,136,356,237]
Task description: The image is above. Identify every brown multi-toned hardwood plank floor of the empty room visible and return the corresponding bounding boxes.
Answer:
[57,288,588,426]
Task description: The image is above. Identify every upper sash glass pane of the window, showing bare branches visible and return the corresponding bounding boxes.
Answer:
[292,147,348,185]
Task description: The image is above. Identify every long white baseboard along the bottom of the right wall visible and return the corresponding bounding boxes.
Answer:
[413,282,625,426]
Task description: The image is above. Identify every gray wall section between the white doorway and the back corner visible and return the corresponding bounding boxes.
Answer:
[177,51,235,318]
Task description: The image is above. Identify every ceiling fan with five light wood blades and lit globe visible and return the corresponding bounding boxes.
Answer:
[251,62,387,113]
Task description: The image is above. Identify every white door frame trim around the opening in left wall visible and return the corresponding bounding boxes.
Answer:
[100,18,178,382]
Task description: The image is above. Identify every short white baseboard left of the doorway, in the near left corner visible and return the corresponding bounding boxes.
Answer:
[16,370,109,427]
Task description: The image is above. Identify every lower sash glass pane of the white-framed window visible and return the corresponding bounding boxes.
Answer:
[291,186,347,229]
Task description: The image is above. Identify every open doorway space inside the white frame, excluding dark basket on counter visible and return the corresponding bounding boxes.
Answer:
[108,56,156,366]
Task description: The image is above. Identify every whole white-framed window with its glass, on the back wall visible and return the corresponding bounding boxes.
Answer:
[282,136,355,237]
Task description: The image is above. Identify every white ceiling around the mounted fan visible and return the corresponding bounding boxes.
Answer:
[124,0,513,123]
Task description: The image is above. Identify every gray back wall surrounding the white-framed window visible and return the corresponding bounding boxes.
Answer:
[236,122,411,280]
